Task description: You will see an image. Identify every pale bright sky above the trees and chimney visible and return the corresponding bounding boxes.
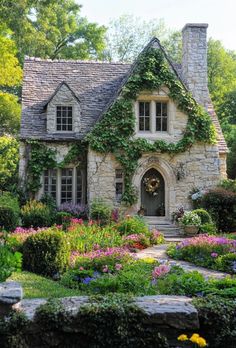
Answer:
[76,0,236,51]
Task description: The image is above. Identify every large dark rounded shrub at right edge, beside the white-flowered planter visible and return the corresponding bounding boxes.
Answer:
[202,188,236,232]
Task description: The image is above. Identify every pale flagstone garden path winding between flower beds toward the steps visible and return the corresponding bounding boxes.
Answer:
[137,242,228,279]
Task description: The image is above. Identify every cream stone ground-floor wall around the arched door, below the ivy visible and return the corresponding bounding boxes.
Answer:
[88,144,226,218]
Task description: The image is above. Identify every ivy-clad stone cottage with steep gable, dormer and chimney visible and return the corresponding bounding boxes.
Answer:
[20,24,227,220]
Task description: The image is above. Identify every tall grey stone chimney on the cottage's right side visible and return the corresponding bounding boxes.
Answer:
[182,23,209,106]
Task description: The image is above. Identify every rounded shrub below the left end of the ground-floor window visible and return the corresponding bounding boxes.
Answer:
[21,200,53,227]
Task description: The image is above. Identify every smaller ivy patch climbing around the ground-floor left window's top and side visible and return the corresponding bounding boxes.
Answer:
[27,140,86,193]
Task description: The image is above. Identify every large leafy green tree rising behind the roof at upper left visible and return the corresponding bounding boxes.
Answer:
[0,0,106,63]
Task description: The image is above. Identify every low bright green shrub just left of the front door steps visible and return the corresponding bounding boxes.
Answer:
[117,216,149,236]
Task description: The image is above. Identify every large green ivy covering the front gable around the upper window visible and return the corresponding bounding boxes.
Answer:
[87,48,216,205]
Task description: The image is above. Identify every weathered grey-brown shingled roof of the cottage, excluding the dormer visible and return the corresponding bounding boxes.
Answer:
[20,38,228,153]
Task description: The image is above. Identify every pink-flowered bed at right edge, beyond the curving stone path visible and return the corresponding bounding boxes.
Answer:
[167,235,236,273]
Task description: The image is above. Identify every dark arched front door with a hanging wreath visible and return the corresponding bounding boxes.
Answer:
[141,168,165,216]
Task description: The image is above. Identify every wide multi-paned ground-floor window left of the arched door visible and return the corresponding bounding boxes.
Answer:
[44,168,85,205]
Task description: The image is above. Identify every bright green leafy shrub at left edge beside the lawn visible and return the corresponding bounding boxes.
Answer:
[0,246,22,283]
